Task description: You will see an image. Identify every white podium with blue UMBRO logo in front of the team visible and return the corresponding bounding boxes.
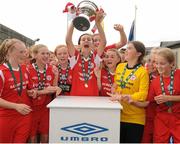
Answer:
[47,96,122,143]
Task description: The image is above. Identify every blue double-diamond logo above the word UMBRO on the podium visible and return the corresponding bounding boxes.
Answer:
[61,123,108,136]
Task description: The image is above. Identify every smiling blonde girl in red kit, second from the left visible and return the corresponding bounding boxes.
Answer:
[28,44,61,143]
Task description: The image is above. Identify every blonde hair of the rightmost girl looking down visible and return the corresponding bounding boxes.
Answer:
[157,48,175,64]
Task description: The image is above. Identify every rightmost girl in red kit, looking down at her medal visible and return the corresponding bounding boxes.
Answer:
[149,48,180,143]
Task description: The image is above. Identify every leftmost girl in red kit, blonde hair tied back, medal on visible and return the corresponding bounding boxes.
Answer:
[0,39,32,143]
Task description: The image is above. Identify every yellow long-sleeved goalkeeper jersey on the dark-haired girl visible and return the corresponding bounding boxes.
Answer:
[114,63,149,125]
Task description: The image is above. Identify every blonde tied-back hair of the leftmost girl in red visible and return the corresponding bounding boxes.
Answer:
[0,38,25,64]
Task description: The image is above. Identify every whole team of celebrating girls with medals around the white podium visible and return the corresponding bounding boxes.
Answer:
[0,8,180,143]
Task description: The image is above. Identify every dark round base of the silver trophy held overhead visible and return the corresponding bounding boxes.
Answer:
[73,16,90,31]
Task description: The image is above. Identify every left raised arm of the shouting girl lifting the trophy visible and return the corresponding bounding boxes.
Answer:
[66,22,76,56]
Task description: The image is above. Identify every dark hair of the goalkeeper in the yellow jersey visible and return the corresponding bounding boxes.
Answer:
[129,41,146,63]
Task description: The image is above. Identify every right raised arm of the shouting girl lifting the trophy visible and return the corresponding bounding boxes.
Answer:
[95,11,106,56]
